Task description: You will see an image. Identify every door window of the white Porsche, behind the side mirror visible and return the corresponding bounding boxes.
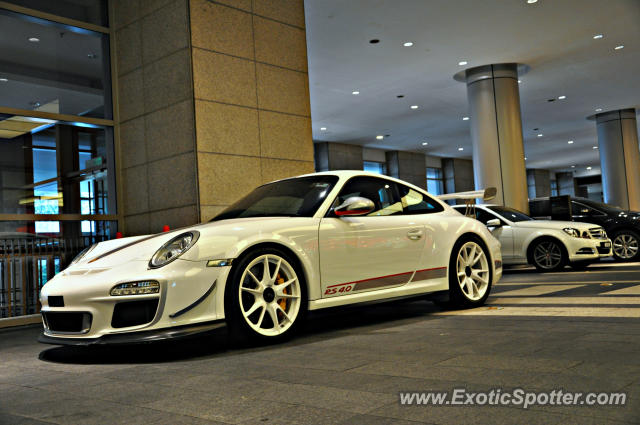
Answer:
[334,177,402,216]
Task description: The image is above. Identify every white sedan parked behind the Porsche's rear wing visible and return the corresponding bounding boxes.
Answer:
[454,204,613,271]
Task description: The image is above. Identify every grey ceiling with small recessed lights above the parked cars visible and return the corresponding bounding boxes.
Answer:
[305,0,640,175]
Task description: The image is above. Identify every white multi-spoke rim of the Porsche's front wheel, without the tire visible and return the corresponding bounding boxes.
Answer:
[238,254,302,337]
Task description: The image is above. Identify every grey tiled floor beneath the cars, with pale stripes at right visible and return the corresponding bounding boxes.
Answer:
[0,265,640,425]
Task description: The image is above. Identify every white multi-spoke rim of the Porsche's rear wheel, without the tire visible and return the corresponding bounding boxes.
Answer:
[456,241,489,301]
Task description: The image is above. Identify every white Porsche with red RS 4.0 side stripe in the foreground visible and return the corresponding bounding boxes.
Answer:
[40,171,502,345]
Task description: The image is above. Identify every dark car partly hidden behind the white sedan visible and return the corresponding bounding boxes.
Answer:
[529,196,640,261]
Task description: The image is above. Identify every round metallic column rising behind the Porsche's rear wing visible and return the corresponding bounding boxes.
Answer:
[456,63,529,212]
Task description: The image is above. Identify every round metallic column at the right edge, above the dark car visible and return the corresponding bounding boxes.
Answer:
[595,109,640,211]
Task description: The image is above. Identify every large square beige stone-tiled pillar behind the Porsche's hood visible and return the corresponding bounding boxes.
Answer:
[109,0,314,235]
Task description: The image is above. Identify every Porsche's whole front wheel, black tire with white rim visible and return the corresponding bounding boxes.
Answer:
[225,248,308,342]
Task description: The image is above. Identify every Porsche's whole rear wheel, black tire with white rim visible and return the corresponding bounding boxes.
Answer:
[447,236,493,308]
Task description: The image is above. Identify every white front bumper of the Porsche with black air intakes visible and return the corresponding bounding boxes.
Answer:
[39,259,230,345]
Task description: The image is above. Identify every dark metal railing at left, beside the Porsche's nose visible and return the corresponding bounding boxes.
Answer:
[0,235,107,318]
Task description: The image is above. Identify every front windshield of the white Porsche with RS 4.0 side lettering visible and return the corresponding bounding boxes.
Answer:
[211,175,338,221]
